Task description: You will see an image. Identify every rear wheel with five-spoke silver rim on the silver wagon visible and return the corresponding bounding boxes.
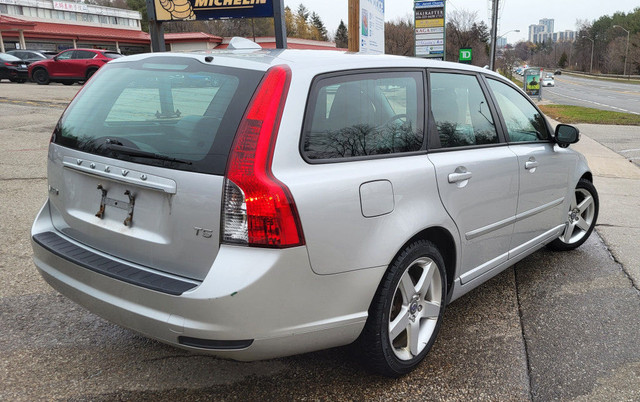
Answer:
[358,240,447,377]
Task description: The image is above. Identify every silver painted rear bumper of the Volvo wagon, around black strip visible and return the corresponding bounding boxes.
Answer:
[32,202,385,360]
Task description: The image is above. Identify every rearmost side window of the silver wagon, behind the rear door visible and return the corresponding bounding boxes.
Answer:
[302,71,424,160]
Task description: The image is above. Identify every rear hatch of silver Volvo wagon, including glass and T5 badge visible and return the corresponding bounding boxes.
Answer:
[49,56,263,279]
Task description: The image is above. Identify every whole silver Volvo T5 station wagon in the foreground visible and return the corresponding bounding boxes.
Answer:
[32,49,598,376]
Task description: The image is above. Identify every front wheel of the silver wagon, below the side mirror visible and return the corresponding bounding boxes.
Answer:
[548,179,600,251]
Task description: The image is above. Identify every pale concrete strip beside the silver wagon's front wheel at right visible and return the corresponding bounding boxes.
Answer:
[550,119,640,289]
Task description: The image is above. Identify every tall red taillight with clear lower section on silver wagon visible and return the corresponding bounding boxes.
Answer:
[222,66,304,248]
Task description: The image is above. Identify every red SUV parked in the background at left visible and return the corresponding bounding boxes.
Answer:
[29,49,122,85]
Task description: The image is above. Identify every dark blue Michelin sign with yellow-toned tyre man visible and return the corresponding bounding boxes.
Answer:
[153,0,273,21]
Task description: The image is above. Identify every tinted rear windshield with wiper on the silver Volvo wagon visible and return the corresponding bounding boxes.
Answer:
[52,56,263,175]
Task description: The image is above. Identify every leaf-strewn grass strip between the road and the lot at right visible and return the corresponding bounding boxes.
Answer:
[539,105,640,126]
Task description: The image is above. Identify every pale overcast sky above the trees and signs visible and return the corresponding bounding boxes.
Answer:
[284,0,640,43]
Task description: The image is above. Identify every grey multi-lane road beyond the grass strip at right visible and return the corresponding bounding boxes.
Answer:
[542,74,640,114]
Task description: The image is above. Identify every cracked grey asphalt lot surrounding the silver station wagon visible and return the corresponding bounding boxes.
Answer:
[0,82,640,401]
